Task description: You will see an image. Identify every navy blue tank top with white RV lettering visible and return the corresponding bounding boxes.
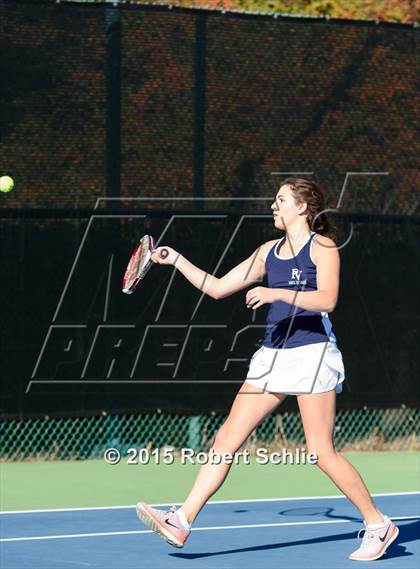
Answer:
[262,231,336,348]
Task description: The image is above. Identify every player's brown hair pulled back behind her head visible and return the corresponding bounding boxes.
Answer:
[280,177,335,239]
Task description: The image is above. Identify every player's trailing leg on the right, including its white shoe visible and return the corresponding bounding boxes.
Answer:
[297,389,399,561]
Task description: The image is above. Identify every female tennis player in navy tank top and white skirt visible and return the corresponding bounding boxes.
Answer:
[137,177,398,561]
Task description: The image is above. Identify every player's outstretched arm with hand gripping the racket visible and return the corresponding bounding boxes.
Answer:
[152,241,275,300]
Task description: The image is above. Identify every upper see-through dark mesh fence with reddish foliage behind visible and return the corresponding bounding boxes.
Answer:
[0,0,420,216]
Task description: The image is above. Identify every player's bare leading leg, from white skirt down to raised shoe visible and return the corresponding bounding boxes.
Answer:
[181,383,287,524]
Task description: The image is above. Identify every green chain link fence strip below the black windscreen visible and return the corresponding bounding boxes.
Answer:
[0,407,420,461]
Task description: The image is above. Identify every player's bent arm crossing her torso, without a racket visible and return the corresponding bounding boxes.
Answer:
[246,235,340,312]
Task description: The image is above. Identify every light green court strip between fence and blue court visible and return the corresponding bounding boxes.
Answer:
[0,451,420,511]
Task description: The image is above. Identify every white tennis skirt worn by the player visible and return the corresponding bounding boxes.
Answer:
[245,341,345,395]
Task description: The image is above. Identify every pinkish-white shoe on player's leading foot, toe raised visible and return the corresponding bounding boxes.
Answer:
[136,502,191,547]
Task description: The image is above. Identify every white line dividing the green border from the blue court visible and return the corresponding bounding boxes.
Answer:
[0,491,420,515]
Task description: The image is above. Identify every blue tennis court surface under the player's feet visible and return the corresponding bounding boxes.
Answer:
[0,492,420,569]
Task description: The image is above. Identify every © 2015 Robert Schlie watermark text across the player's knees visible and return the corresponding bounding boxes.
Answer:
[104,447,318,465]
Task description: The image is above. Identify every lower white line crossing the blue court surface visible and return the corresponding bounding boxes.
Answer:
[0,516,420,543]
